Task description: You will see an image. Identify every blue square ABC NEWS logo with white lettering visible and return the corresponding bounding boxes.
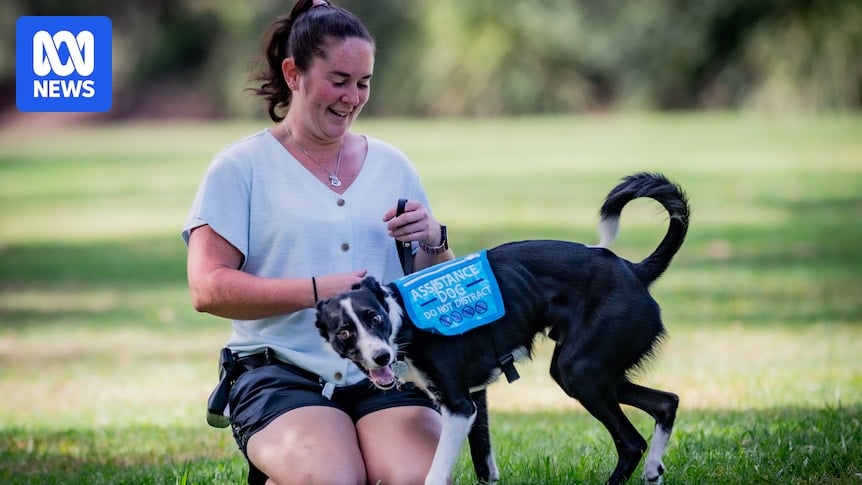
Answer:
[15,16,112,112]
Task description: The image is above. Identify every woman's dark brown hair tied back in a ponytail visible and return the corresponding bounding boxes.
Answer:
[252,0,374,122]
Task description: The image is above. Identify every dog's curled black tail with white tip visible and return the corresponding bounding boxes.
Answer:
[598,173,689,285]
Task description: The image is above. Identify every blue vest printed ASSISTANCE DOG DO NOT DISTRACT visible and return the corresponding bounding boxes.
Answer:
[393,250,506,335]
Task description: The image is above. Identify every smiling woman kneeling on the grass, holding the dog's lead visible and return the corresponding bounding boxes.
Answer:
[183,0,452,485]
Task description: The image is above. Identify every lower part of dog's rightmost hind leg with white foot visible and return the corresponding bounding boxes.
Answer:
[617,381,679,483]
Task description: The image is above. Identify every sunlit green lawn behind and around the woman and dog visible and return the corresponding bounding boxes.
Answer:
[0,114,862,484]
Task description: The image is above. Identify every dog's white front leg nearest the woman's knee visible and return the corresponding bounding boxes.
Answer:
[425,399,476,485]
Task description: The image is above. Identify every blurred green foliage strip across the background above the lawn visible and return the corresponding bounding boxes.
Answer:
[0,0,862,118]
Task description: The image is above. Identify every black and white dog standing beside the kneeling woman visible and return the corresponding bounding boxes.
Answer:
[317,173,689,485]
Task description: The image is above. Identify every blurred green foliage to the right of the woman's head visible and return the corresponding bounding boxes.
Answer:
[388,0,862,115]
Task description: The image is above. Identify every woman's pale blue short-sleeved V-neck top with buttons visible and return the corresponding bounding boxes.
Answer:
[182,130,430,385]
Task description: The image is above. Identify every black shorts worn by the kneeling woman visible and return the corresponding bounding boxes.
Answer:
[230,363,436,464]
